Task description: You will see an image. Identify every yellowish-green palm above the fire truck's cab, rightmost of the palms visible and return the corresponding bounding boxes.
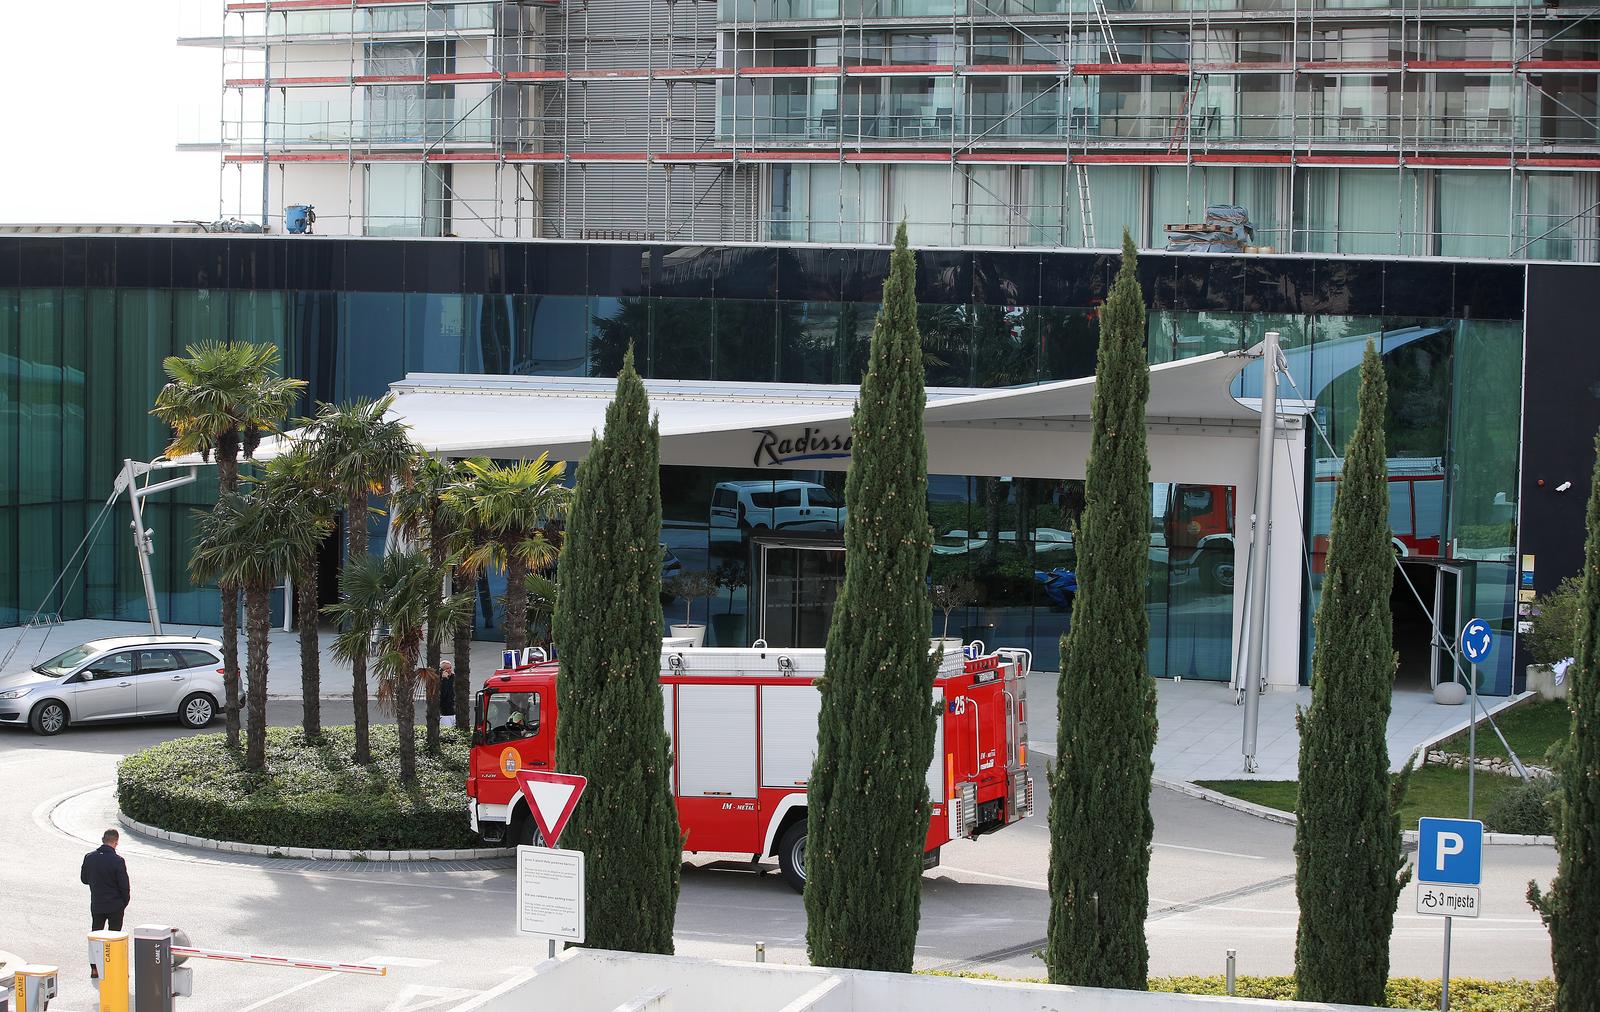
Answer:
[445,453,571,653]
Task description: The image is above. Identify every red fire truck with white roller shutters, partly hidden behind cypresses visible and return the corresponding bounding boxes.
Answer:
[467,642,1034,890]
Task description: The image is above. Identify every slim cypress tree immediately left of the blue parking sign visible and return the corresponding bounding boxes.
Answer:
[1294,343,1410,1006]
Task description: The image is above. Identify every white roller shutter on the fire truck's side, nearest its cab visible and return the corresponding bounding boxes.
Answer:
[677,685,755,797]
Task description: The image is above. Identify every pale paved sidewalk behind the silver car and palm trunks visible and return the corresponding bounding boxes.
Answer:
[0,620,501,700]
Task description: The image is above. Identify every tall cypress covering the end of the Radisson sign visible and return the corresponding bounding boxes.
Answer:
[805,223,938,972]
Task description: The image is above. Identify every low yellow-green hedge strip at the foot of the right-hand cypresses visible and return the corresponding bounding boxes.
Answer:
[923,970,1555,1012]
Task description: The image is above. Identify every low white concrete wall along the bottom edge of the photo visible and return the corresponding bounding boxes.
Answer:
[456,942,1388,1012]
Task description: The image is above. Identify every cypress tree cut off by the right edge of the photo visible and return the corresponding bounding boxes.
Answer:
[1528,437,1600,1012]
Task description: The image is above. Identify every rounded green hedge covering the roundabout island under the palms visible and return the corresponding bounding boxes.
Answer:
[117,725,483,850]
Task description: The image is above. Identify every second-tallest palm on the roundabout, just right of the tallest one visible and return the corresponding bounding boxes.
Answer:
[306,394,416,764]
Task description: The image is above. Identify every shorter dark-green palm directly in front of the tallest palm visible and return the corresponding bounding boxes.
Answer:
[189,492,333,770]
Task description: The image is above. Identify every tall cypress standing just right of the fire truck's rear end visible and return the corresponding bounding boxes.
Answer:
[1045,231,1155,991]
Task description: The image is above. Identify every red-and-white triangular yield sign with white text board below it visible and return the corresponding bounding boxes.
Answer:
[517,770,589,959]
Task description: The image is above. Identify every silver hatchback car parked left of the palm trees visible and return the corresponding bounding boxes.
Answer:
[0,636,222,735]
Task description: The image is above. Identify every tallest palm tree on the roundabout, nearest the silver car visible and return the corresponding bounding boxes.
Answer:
[150,341,306,748]
